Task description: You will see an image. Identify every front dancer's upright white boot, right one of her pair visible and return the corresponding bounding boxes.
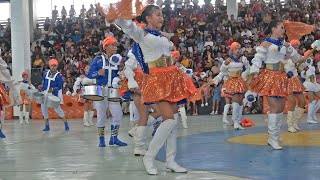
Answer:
[166,123,188,173]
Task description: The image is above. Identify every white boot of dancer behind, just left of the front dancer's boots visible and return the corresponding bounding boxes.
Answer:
[133,126,148,156]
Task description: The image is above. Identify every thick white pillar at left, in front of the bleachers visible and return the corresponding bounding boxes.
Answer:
[10,0,31,116]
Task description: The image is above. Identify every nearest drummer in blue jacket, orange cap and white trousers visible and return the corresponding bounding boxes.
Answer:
[88,36,127,147]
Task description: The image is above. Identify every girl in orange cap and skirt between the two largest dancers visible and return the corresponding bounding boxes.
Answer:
[213,42,250,130]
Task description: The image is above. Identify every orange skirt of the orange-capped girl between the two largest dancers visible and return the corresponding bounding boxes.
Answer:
[224,76,248,95]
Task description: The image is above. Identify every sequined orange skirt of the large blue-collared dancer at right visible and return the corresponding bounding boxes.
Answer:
[251,69,289,97]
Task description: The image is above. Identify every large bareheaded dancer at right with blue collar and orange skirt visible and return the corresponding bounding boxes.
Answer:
[249,20,320,150]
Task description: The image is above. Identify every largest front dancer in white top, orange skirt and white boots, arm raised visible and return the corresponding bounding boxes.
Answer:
[97,4,196,175]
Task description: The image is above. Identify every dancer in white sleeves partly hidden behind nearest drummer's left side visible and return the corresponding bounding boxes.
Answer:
[72,65,94,127]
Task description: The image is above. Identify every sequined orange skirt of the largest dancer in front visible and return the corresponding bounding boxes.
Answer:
[141,66,197,103]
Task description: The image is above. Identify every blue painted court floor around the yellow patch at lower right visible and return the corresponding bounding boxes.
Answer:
[157,124,320,180]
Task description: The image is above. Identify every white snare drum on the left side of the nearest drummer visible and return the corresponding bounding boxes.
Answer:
[83,85,105,101]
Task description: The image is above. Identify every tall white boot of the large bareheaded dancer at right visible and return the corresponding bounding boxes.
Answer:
[268,113,283,150]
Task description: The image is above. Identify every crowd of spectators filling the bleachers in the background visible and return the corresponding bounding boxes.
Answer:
[0,0,320,114]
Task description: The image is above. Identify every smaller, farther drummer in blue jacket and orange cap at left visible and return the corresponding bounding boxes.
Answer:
[39,59,69,131]
